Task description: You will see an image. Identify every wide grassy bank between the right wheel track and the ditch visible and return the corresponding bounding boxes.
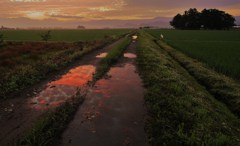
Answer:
[137,32,240,146]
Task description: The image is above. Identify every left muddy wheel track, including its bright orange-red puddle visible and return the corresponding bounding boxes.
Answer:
[0,39,123,145]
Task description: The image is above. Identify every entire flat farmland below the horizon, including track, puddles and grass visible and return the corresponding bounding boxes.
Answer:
[0,29,240,146]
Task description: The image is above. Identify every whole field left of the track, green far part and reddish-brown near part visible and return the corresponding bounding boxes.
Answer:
[0,29,131,98]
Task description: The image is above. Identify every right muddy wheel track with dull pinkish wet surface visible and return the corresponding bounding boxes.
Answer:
[61,40,147,146]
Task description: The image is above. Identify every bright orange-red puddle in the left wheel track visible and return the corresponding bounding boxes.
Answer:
[31,65,95,109]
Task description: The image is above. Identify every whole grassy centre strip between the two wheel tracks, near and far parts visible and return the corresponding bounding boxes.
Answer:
[15,37,130,146]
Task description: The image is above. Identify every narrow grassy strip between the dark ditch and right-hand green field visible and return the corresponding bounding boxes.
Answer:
[154,37,240,116]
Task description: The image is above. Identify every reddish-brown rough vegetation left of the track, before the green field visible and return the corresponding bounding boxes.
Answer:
[0,37,116,99]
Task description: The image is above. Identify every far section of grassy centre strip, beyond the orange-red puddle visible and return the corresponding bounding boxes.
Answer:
[93,37,130,80]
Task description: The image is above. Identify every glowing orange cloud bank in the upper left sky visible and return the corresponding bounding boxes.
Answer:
[0,0,129,20]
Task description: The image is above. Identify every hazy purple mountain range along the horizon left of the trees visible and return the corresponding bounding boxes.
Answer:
[0,17,171,28]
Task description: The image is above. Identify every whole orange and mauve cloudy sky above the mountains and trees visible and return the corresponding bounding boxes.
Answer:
[0,0,240,25]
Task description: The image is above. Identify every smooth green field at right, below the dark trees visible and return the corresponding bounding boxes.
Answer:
[148,30,240,80]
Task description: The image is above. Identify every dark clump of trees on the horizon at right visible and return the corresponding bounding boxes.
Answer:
[170,8,235,29]
